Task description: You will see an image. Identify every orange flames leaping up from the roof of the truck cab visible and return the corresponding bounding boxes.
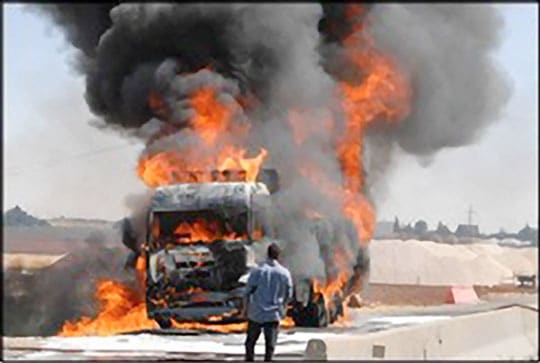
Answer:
[137,82,268,188]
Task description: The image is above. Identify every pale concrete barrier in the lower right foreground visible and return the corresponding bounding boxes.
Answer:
[305,306,538,360]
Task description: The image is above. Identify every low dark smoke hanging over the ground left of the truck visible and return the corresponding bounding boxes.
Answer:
[3,243,132,336]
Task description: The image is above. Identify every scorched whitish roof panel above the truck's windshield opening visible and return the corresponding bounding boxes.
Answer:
[151,182,270,212]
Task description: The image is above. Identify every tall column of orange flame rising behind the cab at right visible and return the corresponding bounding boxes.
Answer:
[337,4,412,245]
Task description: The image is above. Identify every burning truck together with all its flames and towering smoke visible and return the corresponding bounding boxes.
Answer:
[42,3,508,335]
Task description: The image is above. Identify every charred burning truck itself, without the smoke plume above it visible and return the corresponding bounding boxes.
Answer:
[124,169,369,328]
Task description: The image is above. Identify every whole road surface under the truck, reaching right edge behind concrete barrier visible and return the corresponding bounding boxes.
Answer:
[3,294,538,360]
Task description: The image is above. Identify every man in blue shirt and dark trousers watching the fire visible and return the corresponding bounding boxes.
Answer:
[246,243,293,361]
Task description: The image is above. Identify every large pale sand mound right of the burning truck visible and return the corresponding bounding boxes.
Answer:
[370,240,538,286]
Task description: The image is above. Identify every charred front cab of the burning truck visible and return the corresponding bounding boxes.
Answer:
[144,182,270,327]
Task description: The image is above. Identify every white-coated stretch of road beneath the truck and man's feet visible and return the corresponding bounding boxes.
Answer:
[4,314,448,360]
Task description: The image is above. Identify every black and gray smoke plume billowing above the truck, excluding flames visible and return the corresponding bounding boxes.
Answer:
[40,3,509,288]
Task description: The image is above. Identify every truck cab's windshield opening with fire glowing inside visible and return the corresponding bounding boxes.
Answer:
[152,210,248,248]
